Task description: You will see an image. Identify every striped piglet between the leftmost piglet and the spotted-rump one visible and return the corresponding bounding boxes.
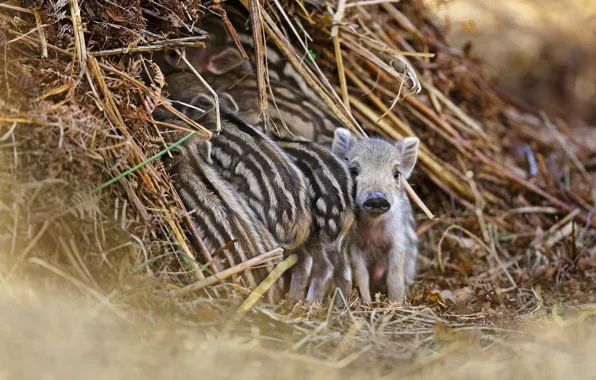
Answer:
[165,94,311,250]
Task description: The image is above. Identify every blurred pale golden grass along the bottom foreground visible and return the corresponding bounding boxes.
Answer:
[0,258,596,380]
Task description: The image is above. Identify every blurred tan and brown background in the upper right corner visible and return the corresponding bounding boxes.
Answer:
[428,0,596,134]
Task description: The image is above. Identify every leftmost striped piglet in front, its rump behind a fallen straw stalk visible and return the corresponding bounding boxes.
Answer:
[166,120,285,302]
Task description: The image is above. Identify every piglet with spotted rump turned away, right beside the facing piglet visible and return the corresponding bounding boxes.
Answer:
[276,139,354,301]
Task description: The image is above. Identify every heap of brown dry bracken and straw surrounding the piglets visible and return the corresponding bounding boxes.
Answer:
[0,0,596,368]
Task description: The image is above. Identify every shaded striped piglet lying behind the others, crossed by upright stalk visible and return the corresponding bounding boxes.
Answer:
[155,5,342,148]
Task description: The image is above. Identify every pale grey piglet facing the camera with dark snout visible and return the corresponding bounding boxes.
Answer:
[333,128,419,303]
